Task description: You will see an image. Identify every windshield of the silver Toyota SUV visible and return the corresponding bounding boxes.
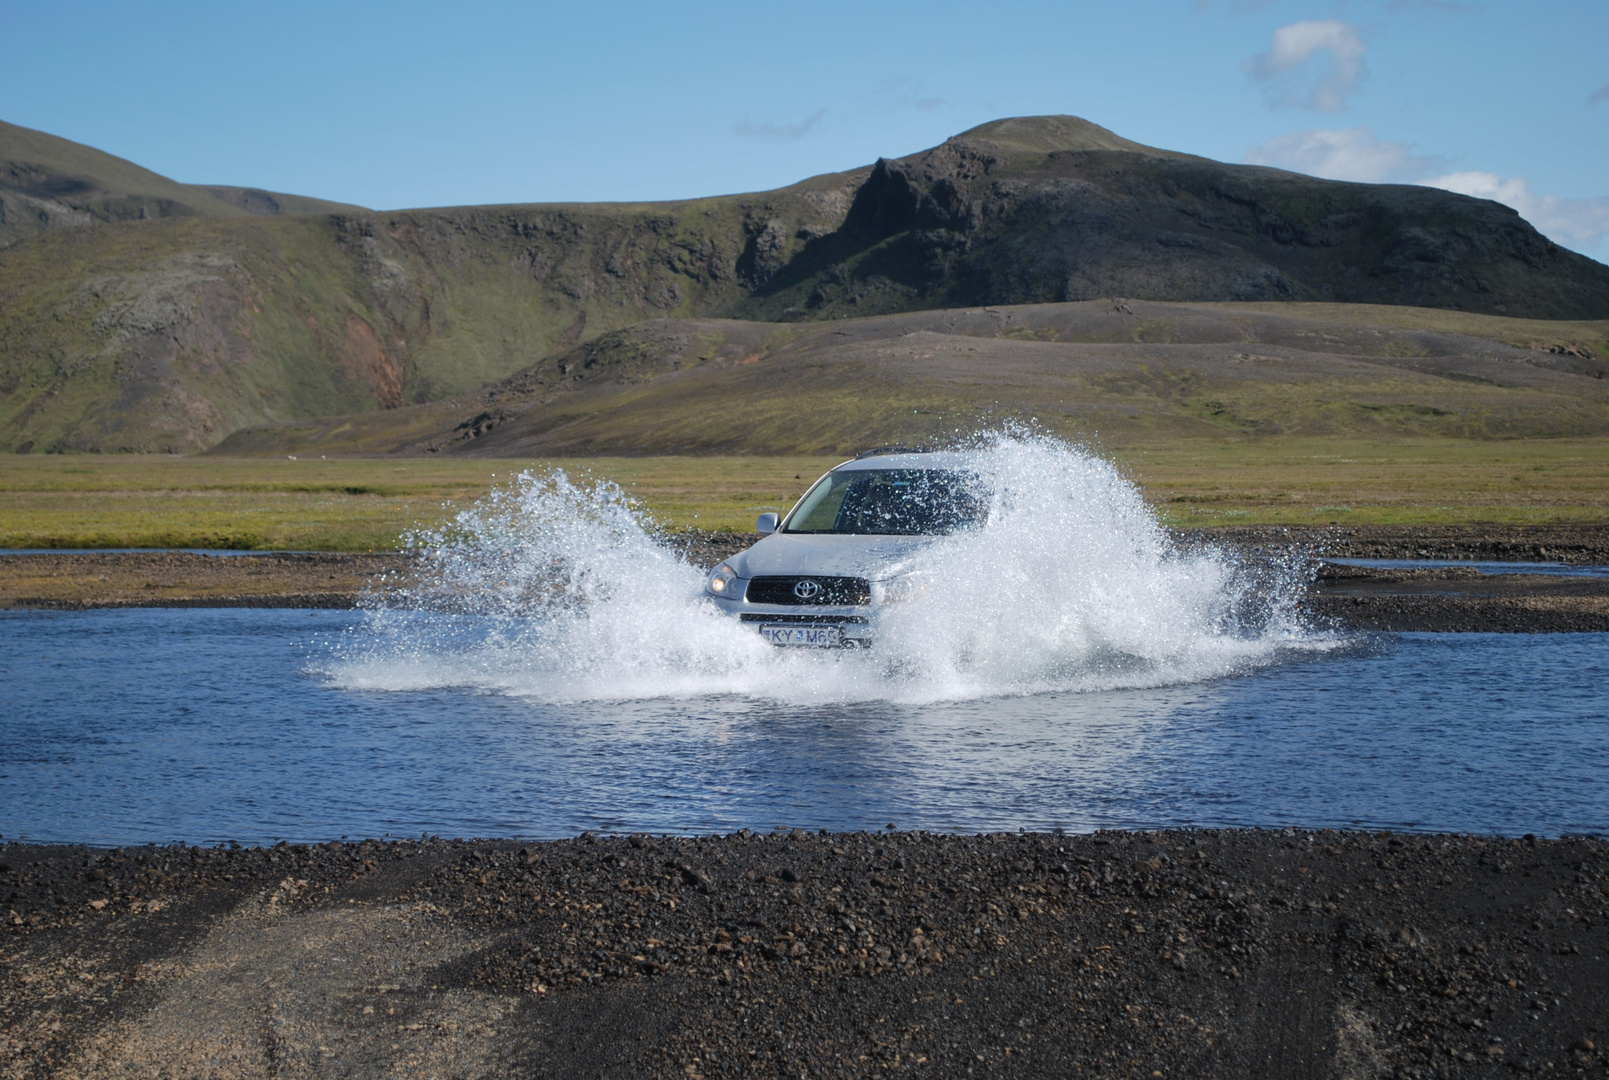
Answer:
[784,468,983,536]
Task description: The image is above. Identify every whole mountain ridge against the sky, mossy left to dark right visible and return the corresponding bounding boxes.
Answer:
[0,116,1609,452]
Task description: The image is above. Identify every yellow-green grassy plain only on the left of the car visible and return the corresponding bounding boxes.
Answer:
[0,454,842,550]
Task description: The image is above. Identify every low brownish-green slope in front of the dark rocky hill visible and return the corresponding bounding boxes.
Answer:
[214,301,1609,457]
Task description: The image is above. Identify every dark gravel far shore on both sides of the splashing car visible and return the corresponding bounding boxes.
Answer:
[0,526,1609,633]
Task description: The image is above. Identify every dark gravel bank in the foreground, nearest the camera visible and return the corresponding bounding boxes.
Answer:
[0,831,1609,1080]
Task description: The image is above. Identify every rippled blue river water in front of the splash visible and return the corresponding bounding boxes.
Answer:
[0,608,1609,843]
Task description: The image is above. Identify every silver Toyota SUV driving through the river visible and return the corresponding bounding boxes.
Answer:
[705,447,986,649]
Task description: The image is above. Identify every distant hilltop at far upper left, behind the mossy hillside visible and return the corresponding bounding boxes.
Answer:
[0,121,357,248]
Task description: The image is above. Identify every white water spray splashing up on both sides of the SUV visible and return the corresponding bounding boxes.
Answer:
[328,435,1339,702]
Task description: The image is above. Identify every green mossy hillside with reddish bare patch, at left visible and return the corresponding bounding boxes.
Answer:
[0,156,866,452]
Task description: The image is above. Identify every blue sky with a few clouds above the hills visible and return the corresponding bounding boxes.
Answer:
[0,0,1609,261]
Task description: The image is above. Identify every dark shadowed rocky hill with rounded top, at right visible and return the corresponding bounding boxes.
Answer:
[759,117,1609,319]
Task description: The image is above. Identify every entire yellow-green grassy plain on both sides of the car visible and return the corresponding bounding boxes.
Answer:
[0,438,1609,550]
